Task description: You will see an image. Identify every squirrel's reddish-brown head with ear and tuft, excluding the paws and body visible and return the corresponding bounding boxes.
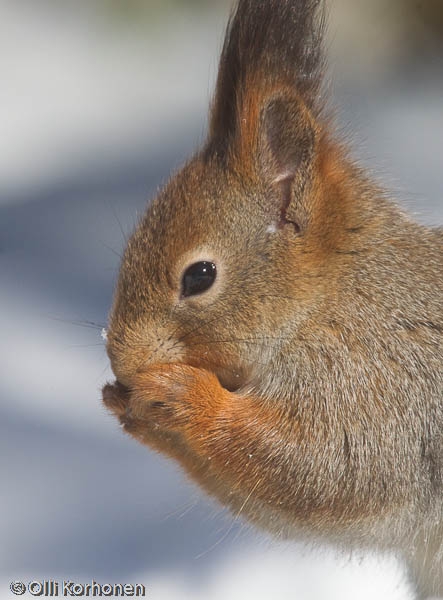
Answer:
[108,0,358,390]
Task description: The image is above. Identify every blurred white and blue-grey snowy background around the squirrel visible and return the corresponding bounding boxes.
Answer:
[0,0,443,600]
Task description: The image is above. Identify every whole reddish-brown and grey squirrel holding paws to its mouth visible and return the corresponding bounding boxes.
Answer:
[103,0,443,598]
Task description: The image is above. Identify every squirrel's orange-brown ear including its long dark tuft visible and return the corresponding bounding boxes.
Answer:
[203,0,324,227]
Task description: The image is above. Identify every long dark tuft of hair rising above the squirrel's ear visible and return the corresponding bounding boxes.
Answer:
[210,0,325,144]
